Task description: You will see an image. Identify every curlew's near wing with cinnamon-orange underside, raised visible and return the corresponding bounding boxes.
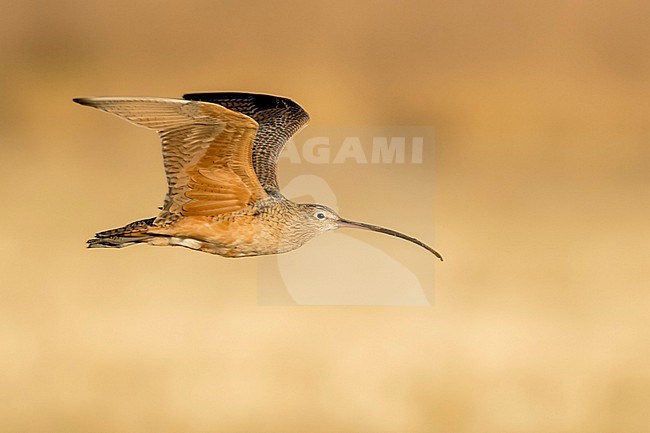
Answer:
[74,97,268,224]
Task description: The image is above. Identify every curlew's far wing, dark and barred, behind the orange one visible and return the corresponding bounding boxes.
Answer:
[183,92,309,195]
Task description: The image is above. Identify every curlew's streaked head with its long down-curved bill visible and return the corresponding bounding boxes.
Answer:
[298,204,442,261]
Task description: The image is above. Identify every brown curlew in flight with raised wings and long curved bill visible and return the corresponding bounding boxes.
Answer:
[74,92,442,260]
